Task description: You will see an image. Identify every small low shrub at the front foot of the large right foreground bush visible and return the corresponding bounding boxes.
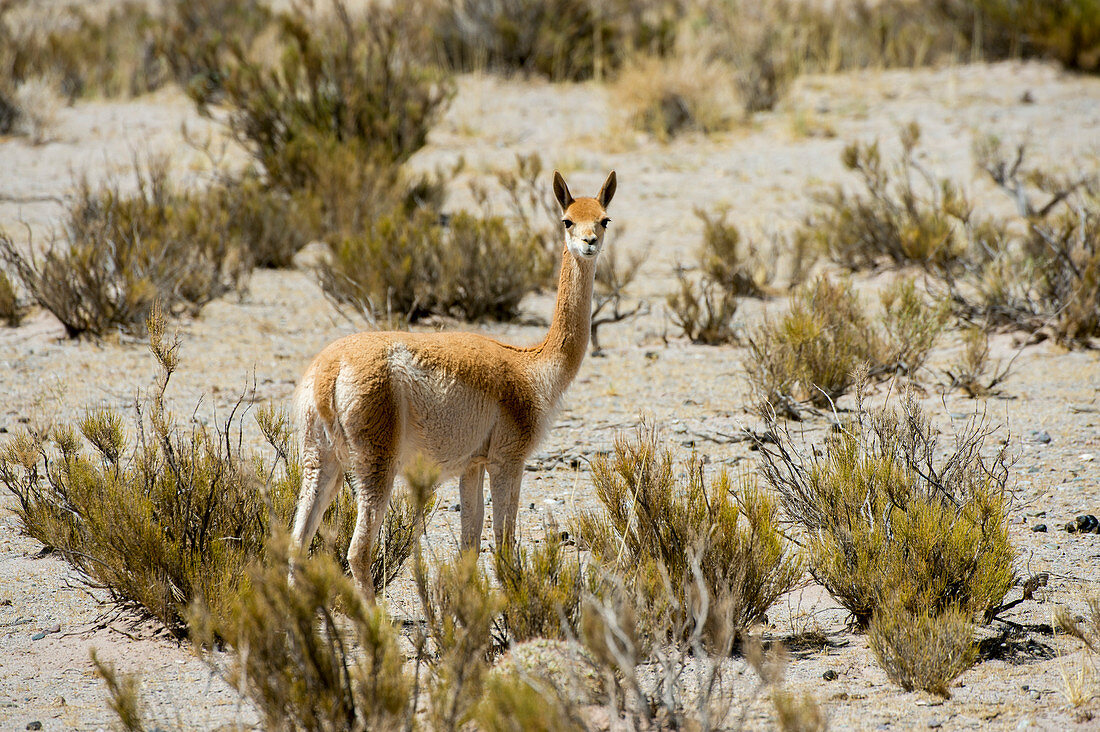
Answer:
[867,604,978,699]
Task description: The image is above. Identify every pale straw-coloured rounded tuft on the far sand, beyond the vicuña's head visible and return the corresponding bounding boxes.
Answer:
[613,54,734,141]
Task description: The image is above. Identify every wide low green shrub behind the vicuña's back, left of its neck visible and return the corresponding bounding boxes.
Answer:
[318,205,549,321]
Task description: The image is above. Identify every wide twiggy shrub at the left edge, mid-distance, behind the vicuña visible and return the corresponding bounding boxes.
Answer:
[0,161,249,337]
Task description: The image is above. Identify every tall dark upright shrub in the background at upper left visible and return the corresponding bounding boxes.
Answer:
[210,0,451,190]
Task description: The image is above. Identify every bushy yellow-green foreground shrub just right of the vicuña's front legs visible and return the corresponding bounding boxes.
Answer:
[574,425,802,644]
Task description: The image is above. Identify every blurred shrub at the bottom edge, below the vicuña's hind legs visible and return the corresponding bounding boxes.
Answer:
[190,540,416,730]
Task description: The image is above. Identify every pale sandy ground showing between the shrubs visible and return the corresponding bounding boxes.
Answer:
[0,63,1100,730]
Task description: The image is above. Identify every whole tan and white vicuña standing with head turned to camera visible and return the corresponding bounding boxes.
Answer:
[292,171,615,598]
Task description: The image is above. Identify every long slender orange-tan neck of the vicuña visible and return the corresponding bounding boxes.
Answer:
[536,247,596,389]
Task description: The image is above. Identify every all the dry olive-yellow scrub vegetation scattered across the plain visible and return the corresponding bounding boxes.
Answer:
[0,0,1100,730]
